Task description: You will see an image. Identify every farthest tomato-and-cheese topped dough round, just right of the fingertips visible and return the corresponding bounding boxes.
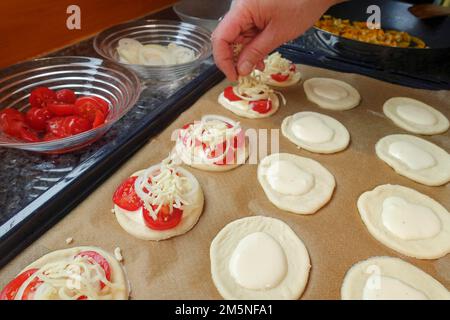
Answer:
[253,52,302,87]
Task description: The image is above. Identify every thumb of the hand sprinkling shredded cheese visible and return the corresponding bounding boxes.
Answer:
[237,27,281,76]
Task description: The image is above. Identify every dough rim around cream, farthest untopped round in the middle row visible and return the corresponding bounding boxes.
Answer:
[303,78,361,110]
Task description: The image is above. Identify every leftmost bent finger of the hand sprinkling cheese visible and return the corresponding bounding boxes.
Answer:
[212,11,241,81]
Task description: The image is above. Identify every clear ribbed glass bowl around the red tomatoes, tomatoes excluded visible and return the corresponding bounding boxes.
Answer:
[0,56,141,153]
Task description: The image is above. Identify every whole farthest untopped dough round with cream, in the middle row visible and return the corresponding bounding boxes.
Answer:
[303,78,361,110]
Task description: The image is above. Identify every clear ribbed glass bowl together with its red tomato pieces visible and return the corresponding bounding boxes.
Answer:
[0,57,141,153]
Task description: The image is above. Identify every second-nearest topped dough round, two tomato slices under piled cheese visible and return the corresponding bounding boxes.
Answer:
[113,159,204,241]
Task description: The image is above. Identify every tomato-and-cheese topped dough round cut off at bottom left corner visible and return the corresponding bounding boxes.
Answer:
[0,247,130,300]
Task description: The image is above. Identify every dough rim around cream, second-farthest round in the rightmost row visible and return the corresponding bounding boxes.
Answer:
[375,134,450,186]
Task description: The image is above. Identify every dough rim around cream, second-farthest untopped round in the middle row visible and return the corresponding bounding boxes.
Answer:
[281,111,350,153]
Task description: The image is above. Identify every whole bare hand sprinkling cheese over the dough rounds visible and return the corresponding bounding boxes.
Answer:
[212,0,339,81]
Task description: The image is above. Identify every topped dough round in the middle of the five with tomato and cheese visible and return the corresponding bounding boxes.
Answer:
[175,115,248,171]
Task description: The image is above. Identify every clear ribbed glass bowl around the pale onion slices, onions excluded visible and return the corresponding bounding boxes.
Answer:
[94,20,212,82]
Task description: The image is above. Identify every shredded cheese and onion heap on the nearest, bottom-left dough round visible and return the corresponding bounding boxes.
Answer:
[16,256,116,300]
